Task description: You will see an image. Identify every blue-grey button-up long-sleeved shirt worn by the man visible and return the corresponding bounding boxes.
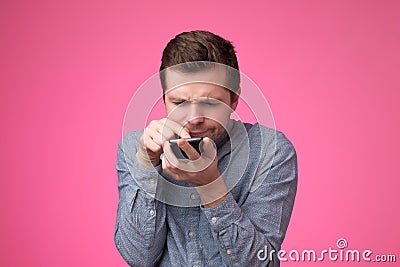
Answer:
[114,121,297,266]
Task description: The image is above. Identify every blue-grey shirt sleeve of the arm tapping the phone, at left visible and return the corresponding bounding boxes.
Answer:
[114,133,167,266]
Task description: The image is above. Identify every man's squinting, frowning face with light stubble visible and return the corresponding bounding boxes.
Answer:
[165,82,238,140]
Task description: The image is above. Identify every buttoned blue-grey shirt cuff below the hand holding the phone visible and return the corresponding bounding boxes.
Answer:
[201,192,242,232]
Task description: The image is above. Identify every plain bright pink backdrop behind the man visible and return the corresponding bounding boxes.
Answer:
[0,0,400,267]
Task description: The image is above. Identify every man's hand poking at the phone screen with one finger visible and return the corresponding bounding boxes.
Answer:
[136,118,190,169]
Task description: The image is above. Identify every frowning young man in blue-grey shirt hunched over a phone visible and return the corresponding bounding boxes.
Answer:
[115,31,297,266]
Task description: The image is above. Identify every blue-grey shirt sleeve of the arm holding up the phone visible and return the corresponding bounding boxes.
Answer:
[202,132,297,266]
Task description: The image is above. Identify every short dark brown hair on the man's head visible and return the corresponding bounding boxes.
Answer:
[160,30,240,99]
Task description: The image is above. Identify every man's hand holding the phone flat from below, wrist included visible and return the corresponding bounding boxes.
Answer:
[162,137,227,207]
